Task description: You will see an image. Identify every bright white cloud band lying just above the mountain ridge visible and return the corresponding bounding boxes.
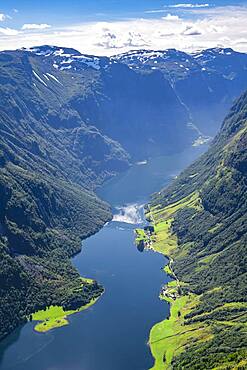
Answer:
[0,6,247,55]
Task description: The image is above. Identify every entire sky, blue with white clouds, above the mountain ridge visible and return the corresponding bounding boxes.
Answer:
[0,0,247,55]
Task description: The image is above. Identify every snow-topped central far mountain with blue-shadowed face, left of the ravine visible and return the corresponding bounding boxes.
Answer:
[19,46,194,159]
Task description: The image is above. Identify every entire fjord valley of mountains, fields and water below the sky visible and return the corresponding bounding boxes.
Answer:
[0,45,247,370]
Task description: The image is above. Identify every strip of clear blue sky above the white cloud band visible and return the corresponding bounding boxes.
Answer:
[0,0,247,26]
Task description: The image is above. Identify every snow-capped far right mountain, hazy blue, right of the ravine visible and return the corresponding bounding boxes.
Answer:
[115,48,247,136]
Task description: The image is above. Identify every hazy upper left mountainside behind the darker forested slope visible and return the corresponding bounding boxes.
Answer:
[0,52,128,188]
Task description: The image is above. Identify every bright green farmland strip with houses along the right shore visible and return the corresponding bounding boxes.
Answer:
[136,192,214,370]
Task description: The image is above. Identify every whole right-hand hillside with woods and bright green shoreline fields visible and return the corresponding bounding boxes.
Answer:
[147,93,247,370]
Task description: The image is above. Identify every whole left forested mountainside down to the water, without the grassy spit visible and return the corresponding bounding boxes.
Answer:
[0,49,129,338]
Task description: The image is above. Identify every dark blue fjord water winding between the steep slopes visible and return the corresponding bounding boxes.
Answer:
[0,148,206,370]
